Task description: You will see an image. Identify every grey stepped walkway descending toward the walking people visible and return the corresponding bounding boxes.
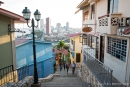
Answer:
[42,67,91,87]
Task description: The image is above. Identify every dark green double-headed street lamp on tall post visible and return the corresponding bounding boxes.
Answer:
[22,7,41,84]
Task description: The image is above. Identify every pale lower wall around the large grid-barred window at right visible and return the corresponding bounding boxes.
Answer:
[104,35,129,83]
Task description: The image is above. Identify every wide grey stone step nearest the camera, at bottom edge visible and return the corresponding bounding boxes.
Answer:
[42,77,91,87]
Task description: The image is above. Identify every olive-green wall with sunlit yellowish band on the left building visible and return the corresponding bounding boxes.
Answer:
[0,15,15,69]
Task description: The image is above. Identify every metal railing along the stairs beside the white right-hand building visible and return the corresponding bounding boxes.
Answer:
[83,48,113,87]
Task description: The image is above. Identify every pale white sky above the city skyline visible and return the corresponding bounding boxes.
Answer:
[0,0,82,28]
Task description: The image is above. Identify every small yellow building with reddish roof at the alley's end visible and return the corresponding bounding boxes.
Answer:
[67,33,82,64]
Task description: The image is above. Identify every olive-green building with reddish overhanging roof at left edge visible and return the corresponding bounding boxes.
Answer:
[0,1,26,86]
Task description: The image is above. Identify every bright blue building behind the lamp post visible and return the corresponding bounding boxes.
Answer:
[16,39,55,78]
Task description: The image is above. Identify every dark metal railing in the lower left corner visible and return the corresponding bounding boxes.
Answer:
[0,65,29,87]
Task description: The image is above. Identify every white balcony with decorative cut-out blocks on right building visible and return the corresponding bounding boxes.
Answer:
[96,13,121,34]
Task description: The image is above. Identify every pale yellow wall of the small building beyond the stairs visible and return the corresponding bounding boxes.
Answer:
[70,36,82,63]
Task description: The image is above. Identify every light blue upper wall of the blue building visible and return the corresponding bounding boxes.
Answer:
[16,41,53,68]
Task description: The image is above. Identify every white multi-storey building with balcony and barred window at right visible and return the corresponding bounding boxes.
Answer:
[76,0,130,87]
